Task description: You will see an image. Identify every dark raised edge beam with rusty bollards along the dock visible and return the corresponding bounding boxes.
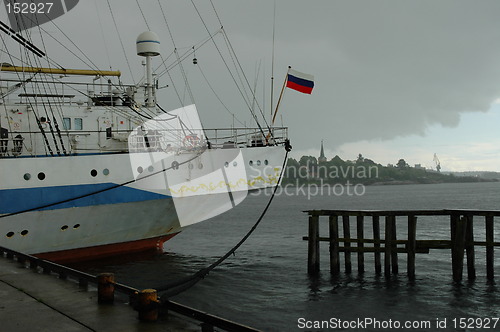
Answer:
[0,247,259,332]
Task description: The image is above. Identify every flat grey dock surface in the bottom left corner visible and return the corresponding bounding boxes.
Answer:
[0,257,201,332]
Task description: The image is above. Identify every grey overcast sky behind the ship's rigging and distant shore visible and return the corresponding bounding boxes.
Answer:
[2,0,500,171]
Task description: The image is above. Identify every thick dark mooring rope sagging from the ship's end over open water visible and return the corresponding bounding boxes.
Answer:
[154,139,292,303]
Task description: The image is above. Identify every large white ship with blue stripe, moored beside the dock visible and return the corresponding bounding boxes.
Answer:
[0,1,289,263]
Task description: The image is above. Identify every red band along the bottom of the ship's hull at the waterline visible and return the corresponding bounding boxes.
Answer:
[33,233,179,264]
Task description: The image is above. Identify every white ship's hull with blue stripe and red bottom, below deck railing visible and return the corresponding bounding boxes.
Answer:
[0,146,285,262]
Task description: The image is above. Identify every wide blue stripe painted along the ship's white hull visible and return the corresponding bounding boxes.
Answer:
[0,183,169,214]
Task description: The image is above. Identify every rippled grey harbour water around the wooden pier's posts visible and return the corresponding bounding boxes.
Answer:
[83,183,500,331]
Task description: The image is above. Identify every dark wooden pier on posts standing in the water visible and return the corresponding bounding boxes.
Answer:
[304,210,500,281]
